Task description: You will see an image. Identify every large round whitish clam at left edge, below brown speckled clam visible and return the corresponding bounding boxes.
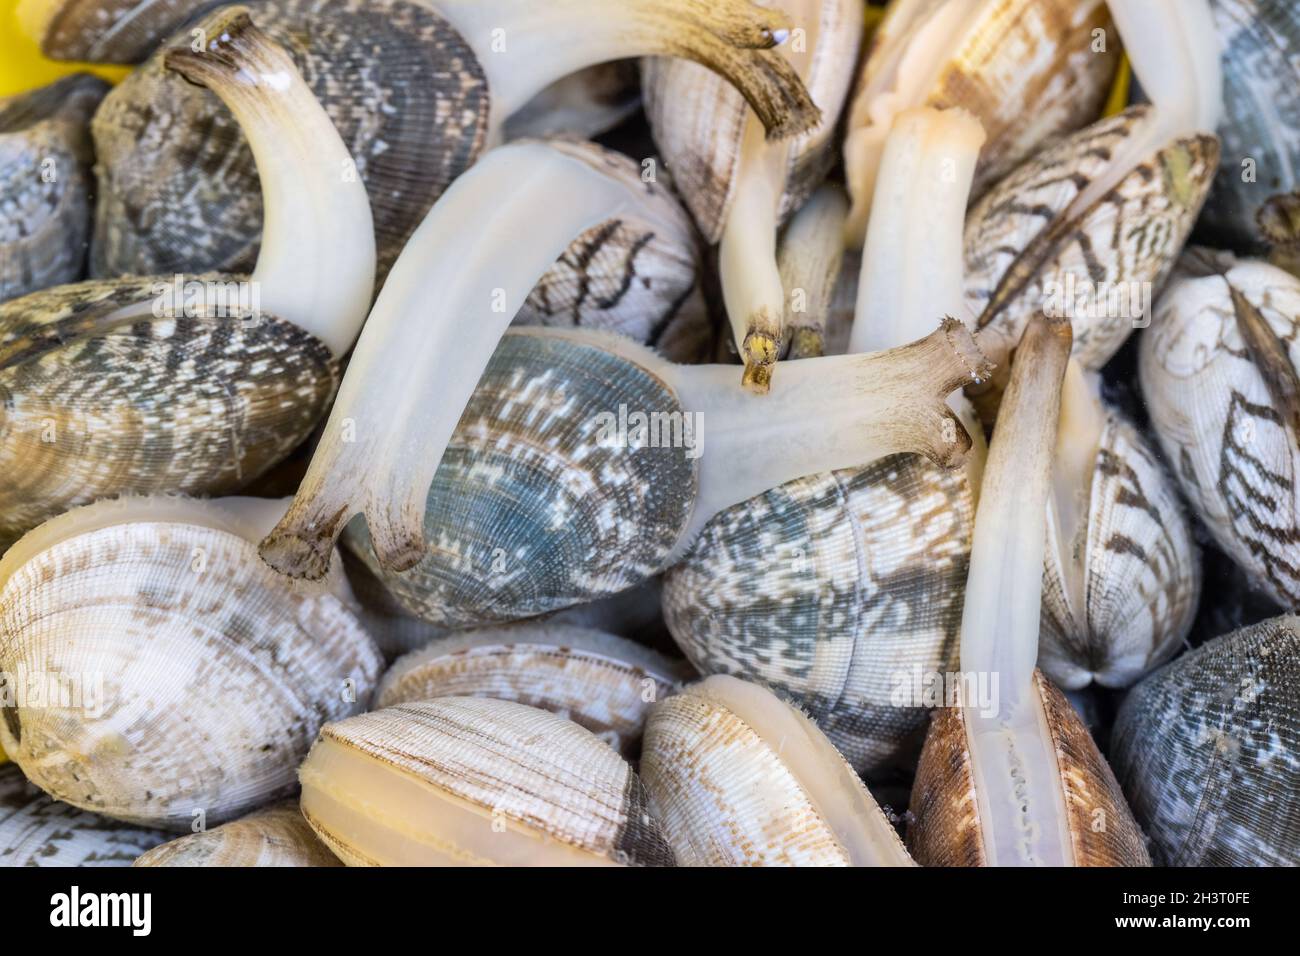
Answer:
[0,498,381,830]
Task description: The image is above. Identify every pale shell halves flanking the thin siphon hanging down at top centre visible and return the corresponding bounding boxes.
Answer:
[641,0,862,243]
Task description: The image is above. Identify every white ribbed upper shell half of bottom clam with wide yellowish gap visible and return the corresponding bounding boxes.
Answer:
[304,697,673,866]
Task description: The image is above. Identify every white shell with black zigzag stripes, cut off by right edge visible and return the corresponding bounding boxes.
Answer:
[1139,251,1300,607]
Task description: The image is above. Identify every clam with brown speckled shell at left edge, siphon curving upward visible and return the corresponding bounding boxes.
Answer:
[0,9,374,540]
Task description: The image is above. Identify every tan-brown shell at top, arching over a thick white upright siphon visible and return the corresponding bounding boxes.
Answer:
[844,0,1119,247]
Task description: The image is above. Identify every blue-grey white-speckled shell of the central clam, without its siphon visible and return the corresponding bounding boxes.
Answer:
[345,333,698,627]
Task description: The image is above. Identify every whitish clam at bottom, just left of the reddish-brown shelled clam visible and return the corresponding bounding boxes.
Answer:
[641,676,911,866]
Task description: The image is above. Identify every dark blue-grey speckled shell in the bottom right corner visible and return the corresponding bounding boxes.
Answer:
[1110,617,1300,866]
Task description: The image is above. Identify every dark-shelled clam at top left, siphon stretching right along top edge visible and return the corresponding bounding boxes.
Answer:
[81,0,810,280]
